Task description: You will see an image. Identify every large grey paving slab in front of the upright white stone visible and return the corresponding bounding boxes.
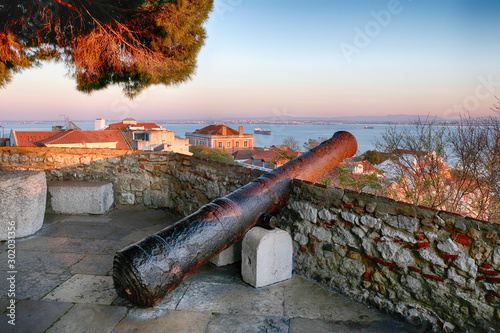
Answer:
[177,282,284,316]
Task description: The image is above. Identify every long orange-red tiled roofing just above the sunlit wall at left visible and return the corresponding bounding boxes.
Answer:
[15,130,129,149]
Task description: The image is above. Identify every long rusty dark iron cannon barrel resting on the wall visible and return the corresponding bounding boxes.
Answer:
[113,132,357,306]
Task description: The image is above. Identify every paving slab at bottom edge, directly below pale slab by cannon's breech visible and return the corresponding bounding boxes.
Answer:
[47,304,127,333]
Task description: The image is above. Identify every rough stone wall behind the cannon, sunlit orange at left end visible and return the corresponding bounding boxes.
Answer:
[0,147,263,215]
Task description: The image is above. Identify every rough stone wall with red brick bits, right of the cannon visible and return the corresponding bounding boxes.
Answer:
[278,181,500,332]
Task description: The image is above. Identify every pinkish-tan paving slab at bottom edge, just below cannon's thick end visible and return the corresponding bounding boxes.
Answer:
[113,308,210,333]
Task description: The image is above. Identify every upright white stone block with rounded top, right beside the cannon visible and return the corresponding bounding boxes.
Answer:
[241,227,293,287]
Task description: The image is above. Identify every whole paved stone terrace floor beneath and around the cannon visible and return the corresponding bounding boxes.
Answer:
[0,208,424,333]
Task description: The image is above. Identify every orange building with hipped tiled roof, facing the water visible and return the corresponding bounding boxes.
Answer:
[186,124,254,153]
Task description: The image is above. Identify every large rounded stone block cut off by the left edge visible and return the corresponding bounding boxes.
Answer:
[0,171,47,240]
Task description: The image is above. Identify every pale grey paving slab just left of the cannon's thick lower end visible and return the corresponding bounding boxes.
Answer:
[44,274,116,305]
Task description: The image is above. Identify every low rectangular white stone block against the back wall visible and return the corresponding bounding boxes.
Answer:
[47,181,114,214]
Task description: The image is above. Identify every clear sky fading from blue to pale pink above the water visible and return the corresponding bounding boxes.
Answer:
[0,0,500,121]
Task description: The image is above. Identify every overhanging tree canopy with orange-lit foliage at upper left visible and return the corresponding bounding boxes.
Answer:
[0,0,213,97]
